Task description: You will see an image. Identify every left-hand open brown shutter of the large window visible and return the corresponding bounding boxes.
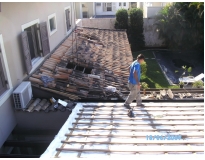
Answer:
[21,31,32,74]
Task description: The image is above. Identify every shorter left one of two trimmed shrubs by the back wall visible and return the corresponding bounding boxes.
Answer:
[115,9,128,29]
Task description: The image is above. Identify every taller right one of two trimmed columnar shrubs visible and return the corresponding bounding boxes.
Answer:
[129,8,145,51]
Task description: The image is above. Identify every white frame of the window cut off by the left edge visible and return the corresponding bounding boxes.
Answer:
[0,34,13,107]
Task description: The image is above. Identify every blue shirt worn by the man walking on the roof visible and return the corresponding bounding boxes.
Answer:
[128,61,141,85]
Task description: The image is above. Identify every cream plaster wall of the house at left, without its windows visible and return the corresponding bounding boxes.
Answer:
[0,2,75,147]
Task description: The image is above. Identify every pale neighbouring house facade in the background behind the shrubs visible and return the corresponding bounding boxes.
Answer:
[75,2,172,19]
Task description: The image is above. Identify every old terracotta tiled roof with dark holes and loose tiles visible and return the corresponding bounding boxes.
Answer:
[29,28,133,100]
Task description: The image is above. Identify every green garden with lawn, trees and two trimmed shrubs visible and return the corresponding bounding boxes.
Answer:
[115,2,204,88]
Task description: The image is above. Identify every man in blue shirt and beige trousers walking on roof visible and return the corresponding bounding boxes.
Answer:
[124,54,145,117]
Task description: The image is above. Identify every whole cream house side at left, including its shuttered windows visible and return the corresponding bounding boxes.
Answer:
[0,2,76,147]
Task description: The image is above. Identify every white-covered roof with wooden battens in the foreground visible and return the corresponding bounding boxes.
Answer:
[41,102,204,159]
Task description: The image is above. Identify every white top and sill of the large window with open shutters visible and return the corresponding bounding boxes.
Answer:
[21,19,46,74]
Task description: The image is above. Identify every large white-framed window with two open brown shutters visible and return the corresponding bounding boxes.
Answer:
[21,19,50,74]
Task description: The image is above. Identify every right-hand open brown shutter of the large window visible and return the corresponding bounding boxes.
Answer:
[40,22,50,56]
